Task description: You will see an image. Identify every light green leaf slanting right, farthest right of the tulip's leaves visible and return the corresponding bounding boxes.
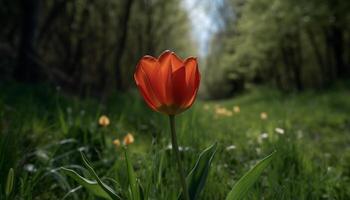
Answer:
[226,151,276,200]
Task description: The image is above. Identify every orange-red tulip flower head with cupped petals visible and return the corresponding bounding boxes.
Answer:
[134,51,200,115]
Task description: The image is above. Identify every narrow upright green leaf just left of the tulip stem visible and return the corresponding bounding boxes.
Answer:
[124,148,140,200]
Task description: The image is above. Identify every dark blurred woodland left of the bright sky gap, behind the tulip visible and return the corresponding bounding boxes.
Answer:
[0,0,194,96]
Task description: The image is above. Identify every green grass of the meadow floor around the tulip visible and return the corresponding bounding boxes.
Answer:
[0,84,350,200]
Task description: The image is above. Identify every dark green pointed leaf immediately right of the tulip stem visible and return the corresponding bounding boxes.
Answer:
[180,143,217,200]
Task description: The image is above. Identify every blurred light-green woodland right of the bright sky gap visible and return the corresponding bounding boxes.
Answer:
[204,0,350,97]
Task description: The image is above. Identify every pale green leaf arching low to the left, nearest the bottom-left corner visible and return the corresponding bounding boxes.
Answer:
[61,167,112,200]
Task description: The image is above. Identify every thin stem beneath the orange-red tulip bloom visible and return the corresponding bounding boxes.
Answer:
[169,115,190,200]
